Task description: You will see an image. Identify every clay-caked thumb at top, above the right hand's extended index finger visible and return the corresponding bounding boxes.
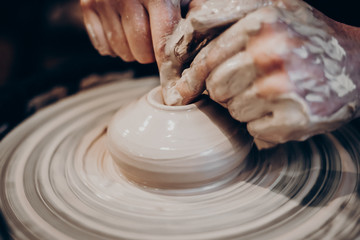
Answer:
[169,0,272,70]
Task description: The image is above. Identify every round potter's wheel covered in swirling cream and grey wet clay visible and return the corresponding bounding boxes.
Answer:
[0,78,360,239]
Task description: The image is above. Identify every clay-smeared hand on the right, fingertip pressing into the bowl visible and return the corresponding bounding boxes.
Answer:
[161,0,360,148]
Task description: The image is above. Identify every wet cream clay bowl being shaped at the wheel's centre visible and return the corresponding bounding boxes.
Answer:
[107,87,252,190]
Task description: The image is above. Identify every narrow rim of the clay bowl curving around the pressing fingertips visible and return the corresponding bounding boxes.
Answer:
[146,86,205,111]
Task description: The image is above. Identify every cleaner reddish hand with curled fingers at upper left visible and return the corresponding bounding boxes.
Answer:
[81,0,188,63]
